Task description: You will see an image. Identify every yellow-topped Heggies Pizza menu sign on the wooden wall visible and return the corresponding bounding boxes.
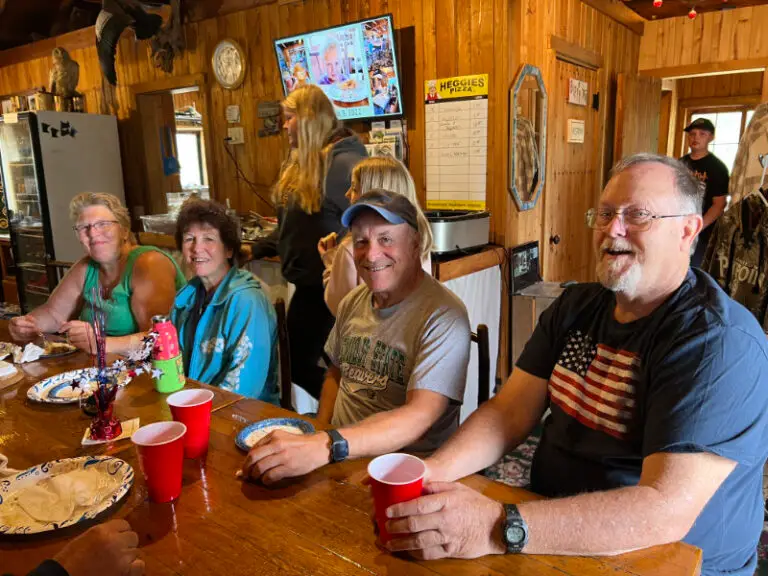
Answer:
[424,74,488,210]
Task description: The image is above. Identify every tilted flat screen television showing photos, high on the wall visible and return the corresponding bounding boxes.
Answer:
[275,14,403,120]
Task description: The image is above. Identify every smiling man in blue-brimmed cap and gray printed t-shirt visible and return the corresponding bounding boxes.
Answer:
[242,190,470,485]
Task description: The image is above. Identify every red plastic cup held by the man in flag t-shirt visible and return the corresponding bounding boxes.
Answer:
[368,454,427,543]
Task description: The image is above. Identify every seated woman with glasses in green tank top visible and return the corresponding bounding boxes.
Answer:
[9,193,186,354]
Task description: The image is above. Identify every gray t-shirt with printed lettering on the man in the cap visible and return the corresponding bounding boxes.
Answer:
[325,274,470,452]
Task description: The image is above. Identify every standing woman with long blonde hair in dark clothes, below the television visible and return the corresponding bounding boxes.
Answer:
[253,85,366,398]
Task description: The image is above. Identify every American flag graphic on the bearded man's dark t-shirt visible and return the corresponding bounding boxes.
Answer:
[549,330,640,439]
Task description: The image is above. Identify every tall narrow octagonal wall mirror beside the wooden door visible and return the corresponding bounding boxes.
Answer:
[509,64,547,210]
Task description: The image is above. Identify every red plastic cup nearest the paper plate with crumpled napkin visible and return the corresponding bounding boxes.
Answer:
[131,422,187,502]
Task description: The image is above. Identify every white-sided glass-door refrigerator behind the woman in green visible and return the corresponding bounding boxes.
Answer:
[0,112,125,312]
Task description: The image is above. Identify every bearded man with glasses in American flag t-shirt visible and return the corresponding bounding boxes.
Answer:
[387,154,768,576]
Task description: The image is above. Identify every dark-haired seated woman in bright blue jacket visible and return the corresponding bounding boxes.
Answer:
[171,200,278,404]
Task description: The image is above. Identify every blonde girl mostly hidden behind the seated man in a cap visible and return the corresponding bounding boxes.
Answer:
[317,156,432,316]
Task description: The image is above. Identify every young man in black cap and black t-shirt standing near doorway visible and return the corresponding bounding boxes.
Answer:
[680,118,728,266]
